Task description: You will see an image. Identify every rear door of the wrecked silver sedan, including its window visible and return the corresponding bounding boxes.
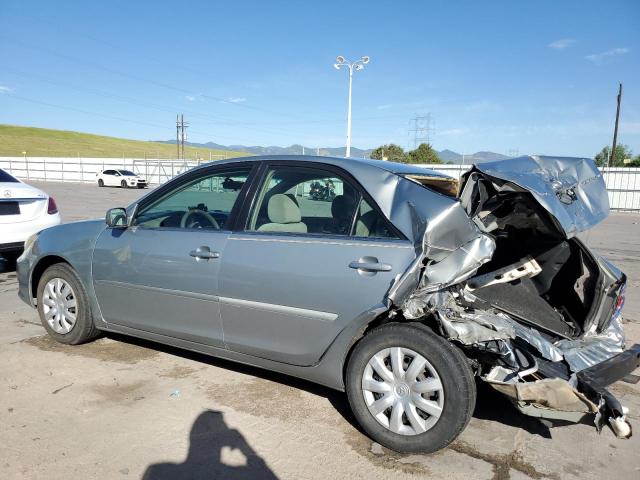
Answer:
[219,162,415,365]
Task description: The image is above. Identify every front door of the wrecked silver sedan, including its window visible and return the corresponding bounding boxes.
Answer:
[93,166,251,347]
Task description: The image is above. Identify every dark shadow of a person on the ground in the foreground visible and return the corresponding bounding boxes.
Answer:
[142,410,278,480]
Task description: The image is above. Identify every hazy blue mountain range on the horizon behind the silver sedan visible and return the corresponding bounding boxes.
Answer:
[160,140,509,164]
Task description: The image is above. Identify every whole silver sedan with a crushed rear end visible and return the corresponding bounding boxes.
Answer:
[17,156,640,452]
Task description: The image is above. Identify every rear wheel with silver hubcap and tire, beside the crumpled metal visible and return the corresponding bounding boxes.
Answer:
[346,323,476,453]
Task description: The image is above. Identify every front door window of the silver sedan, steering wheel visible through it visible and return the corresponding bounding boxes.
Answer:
[134,167,251,230]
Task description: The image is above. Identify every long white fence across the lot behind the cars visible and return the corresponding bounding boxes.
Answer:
[0,157,640,212]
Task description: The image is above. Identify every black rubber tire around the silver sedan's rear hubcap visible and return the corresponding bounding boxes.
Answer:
[345,323,476,453]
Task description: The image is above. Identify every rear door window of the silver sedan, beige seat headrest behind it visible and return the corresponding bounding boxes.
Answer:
[247,166,398,237]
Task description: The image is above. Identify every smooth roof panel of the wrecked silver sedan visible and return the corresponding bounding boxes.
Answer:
[202,155,449,178]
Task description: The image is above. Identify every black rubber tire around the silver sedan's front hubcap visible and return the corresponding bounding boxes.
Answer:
[37,263,100,345]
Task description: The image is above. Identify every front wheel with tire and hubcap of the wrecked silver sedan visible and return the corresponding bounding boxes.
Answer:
[37,263,99,345]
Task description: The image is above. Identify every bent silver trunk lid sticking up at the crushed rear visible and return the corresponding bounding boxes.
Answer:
[462,155,609,238]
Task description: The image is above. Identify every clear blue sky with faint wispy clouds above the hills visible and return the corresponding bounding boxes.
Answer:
[0,0,640,156]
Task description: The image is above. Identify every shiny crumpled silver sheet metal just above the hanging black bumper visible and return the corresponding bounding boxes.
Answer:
[555,315,625,372]
